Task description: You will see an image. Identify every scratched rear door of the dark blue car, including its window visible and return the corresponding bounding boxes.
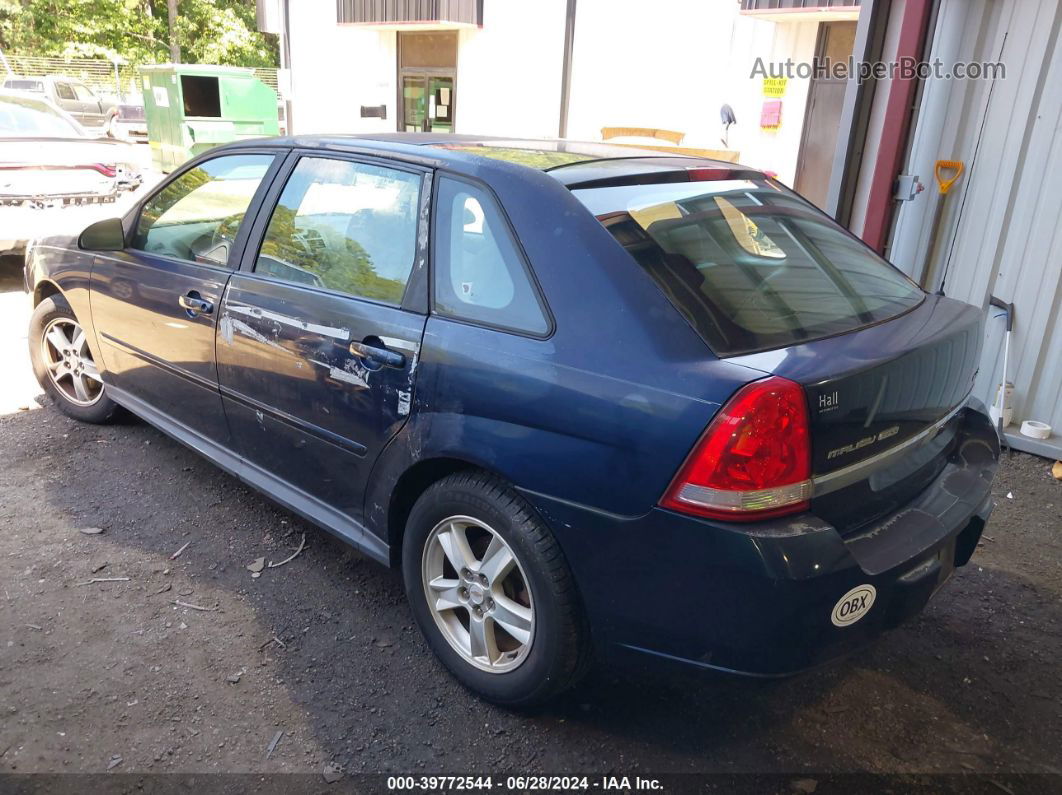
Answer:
[218,152,430,526]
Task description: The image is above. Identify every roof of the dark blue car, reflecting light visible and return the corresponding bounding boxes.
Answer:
[212,133,761,188]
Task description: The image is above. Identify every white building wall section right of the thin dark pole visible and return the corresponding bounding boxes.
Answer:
[568,0,818,185]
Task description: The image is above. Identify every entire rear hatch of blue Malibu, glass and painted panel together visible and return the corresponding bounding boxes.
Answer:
[568,161,981,531]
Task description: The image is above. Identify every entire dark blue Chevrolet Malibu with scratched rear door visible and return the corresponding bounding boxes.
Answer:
[27,135,998,705]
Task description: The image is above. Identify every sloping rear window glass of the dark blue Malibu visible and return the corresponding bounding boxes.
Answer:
[573,175,923,356]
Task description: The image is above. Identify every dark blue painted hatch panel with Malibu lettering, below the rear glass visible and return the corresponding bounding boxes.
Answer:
[737,296,981,532]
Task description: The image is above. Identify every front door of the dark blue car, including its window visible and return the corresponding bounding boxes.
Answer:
[91,150,282,446]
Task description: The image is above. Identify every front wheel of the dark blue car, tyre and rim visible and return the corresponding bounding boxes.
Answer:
[30,295,118,422]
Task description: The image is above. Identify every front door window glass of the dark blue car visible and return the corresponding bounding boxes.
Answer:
[133,155,273,266]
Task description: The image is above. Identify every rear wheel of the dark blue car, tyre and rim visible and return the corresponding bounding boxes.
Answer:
[402,473,588,706]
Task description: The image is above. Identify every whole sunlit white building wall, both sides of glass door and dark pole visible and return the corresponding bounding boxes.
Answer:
[290,0,818,184]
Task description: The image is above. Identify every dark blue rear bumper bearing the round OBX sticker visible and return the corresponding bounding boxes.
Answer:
[528,408,999,676]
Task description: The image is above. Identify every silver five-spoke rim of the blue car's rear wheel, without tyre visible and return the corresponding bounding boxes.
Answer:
[421,516,534,673]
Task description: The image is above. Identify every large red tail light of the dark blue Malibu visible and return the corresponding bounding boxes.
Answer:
[661,376,811,521]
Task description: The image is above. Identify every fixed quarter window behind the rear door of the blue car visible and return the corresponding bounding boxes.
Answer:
[434,176,549,335]
